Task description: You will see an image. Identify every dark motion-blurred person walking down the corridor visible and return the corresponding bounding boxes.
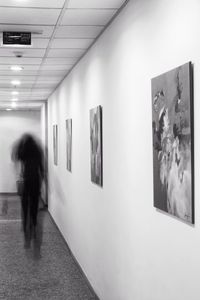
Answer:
[12,133,44,248]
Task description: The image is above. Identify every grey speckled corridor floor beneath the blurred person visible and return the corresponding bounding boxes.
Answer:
[0,195,98,300]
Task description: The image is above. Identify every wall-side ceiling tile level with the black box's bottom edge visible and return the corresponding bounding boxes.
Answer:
[51,39,93,49]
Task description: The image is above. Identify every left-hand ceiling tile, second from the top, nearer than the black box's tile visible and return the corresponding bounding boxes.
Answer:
[0,7,60,25]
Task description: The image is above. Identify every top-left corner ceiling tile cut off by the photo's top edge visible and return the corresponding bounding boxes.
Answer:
[0,0,65,8]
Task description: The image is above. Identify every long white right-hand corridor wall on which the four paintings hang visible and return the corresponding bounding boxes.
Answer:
[48,0,200,300]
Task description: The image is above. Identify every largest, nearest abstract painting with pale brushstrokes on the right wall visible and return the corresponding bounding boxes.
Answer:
[152,63,194,223]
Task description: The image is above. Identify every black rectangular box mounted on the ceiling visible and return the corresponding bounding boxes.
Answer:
[3,31,31,46]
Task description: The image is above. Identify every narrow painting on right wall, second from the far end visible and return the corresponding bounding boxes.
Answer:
[66,119,72,172]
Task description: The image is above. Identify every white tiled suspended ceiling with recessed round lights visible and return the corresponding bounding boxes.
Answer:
[0,0,127,107]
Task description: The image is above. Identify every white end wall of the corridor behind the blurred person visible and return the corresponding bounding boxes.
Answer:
[0,110,41,193]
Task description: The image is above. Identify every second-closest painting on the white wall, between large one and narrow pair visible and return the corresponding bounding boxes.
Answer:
[90,106,103,186]
